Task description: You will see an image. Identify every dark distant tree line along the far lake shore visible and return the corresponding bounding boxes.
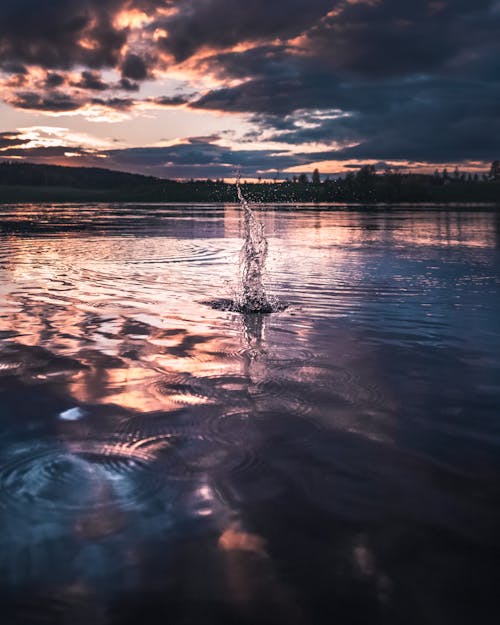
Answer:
[0,161,500,203]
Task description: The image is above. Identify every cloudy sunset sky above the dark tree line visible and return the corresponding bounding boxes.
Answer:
[0,0,500,179]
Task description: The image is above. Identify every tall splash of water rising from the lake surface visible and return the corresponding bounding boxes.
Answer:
[236,175,273,313]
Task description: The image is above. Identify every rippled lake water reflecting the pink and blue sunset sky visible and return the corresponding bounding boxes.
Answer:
[0,206,500,625]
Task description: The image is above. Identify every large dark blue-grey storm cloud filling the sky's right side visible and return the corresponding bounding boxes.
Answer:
[187,0,500,162]
